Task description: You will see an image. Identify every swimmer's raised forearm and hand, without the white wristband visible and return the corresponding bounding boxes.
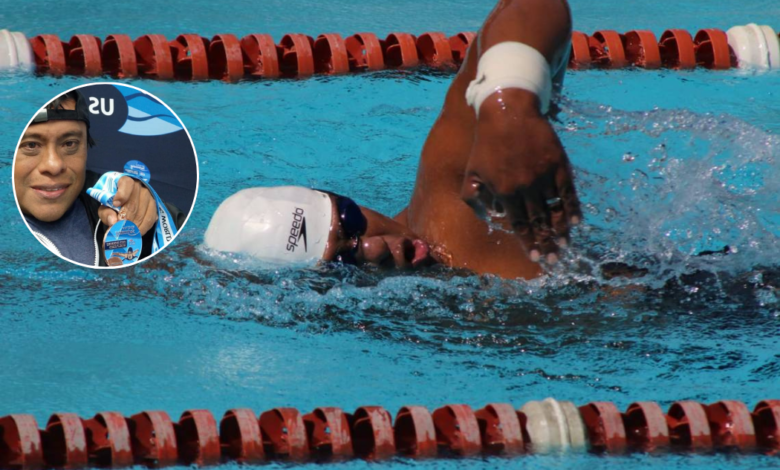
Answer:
[461,0,582,262]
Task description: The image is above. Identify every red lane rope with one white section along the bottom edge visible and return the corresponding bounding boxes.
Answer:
[0,398,780,470]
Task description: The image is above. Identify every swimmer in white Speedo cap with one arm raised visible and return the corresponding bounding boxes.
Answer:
[205,0,582,279]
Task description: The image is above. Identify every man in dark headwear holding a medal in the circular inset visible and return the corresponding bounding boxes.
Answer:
[14,90,186,266]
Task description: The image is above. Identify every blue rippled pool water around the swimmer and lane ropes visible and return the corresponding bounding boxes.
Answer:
[0,0,780,469]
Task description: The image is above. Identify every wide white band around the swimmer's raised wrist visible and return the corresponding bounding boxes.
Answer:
[466,41,552,116]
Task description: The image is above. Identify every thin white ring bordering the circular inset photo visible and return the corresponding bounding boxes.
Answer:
[11,82,200,270]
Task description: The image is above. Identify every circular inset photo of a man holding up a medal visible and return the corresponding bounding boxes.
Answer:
[13,83,198,268]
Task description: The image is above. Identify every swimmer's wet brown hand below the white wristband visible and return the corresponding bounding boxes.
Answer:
[461,89,582,262]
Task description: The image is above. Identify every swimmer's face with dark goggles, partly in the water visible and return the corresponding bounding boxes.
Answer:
[323,194,432,269]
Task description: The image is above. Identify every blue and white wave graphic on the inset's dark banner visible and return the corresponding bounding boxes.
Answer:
[116,86,184,136]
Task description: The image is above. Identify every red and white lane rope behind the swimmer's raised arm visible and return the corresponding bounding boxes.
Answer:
[0,23,780,82]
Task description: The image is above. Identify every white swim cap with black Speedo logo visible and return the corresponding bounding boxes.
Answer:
[205,186,333,264]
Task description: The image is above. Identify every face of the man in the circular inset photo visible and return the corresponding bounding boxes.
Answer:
[14,100,87,222]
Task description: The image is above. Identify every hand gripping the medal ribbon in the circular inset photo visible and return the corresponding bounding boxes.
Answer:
[98,176,157,236]
